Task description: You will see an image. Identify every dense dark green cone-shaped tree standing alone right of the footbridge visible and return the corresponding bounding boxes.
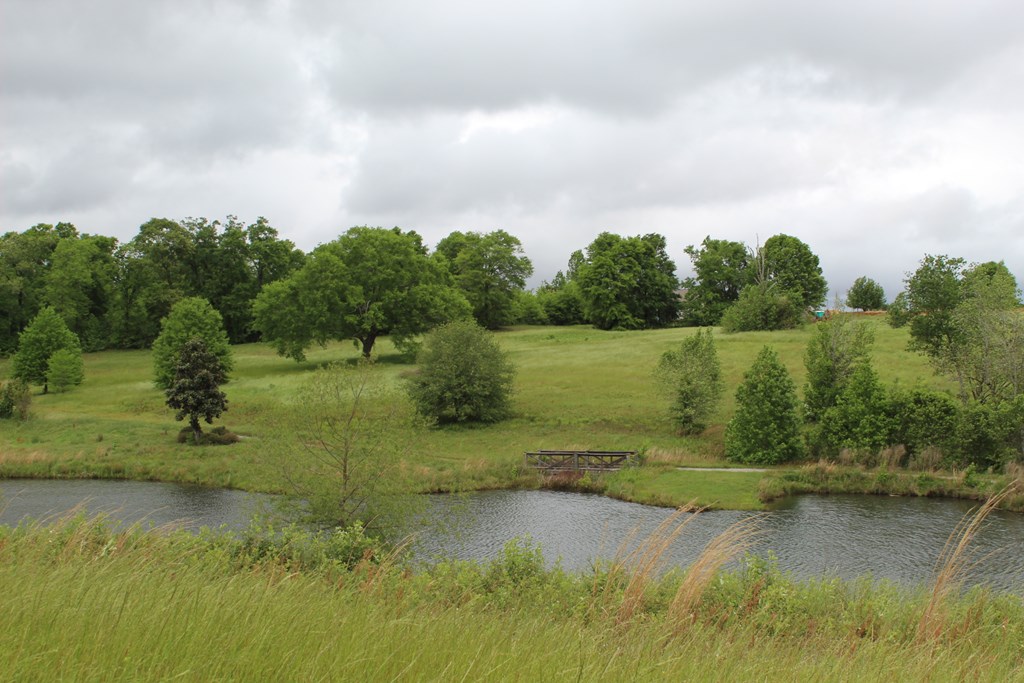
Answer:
[725,346,804,465]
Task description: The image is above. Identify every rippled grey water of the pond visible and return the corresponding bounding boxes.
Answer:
[6,480,1024,593]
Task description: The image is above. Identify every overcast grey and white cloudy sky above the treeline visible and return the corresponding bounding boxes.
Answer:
[0,0,1024,298]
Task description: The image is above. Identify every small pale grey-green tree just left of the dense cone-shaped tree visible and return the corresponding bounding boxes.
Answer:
[654,330,723,434]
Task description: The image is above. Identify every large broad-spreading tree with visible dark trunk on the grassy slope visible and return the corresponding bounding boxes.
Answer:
[253,227,470,360]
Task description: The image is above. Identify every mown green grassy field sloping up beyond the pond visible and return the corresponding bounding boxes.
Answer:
[0,318,978,509]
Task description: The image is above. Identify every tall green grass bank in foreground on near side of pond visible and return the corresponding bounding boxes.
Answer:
[0,509,1024,681]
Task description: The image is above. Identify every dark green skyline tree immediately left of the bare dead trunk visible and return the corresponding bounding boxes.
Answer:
[682,236,751,326]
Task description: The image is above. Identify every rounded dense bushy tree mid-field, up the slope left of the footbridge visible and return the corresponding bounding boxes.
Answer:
[408,321,515,423]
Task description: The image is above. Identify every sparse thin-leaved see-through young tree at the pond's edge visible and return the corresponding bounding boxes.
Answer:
[282,358,416,536]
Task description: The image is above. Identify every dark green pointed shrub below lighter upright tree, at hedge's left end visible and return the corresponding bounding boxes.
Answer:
[820,361,893,455]
